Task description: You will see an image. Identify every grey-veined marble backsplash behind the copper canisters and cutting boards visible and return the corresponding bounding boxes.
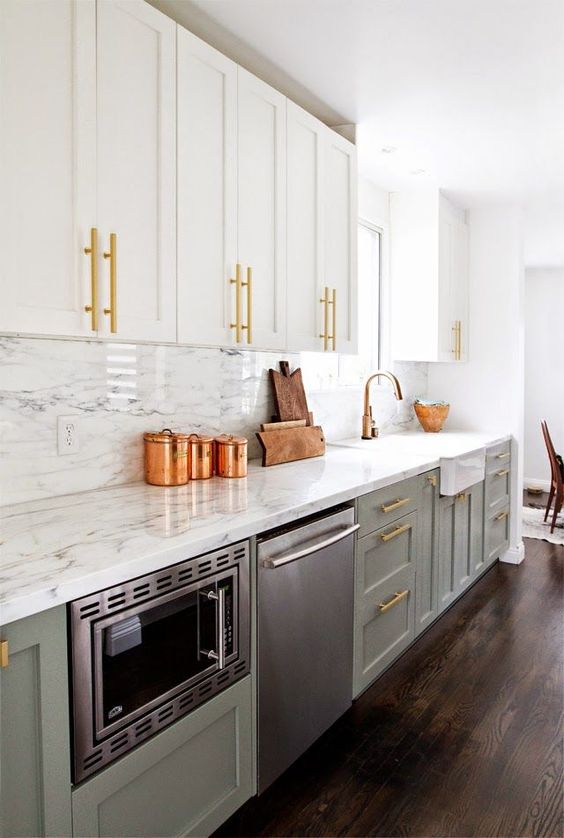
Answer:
[0,337,427,505]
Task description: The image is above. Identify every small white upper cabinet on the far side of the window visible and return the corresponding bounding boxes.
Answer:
[390,190,468,361]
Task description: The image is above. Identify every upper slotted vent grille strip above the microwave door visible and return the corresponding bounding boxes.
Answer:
[71,541,249,620]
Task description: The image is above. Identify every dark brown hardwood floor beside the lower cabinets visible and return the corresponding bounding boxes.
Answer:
[217,539,564,836]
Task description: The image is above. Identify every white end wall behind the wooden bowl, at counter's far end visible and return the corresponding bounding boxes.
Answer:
[428,206,524,561]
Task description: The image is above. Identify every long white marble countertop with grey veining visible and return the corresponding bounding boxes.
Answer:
[0,431,508,625]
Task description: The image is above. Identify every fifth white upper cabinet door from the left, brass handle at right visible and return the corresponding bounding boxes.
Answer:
[286,101,331,352]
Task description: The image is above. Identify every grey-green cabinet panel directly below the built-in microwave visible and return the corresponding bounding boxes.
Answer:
[72,676,254,838]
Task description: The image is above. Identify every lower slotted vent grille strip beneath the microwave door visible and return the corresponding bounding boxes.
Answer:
[74,660,249,783]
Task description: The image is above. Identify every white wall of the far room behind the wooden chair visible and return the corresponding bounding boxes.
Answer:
[525,267,564,489]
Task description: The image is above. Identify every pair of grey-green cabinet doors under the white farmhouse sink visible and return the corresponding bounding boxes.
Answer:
[438,482,485,613]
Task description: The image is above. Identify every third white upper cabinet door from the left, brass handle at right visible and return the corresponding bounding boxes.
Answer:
[177,27,237,345]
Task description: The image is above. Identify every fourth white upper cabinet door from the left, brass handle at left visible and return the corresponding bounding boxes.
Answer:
[237,67,286,349]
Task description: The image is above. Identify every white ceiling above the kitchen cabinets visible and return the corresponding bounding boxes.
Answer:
[155,0,564,207]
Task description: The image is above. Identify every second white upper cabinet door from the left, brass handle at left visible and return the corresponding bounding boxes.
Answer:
[97,0,176,341]
